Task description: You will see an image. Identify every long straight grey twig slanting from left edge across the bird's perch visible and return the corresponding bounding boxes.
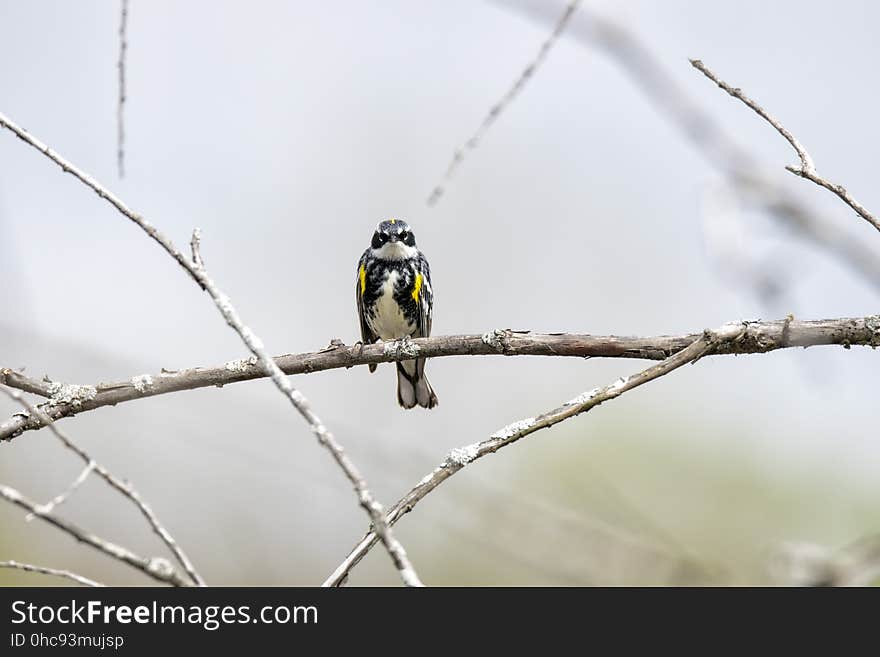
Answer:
[0,114,421,586]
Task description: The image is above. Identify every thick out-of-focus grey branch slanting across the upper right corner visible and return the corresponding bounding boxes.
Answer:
[493,0,880,289]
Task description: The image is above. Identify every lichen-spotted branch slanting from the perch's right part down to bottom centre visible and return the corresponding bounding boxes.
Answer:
[324,322,748,586]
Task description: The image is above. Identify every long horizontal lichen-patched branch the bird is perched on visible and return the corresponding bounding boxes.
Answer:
[0,315,880,440]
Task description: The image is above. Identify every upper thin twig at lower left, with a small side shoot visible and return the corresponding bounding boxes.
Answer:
[0,386,205,586]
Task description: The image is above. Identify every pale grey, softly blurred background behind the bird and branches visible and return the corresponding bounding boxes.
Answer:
[0,0,880,585]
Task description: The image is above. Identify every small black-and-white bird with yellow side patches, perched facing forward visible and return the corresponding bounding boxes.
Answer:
[356,219,437,408]
